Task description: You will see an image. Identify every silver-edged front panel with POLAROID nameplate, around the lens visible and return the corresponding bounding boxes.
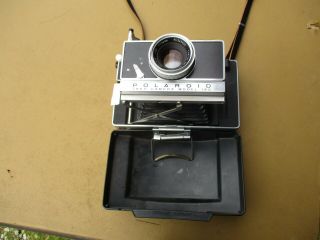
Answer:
[113,34,225,105]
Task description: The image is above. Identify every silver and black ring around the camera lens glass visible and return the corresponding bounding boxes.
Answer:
[148,33,196,80]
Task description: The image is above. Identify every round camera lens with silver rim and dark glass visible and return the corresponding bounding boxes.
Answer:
[149,34,195,80]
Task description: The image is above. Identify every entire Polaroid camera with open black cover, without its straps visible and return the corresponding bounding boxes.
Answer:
[103,30,244,220]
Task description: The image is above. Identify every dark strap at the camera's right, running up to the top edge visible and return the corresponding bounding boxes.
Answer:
[226,0,253,60]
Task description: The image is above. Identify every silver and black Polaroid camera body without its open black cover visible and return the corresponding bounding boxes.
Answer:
[111,34,240,129]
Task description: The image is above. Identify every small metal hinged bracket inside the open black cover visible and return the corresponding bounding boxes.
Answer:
[151,128,193,161]
